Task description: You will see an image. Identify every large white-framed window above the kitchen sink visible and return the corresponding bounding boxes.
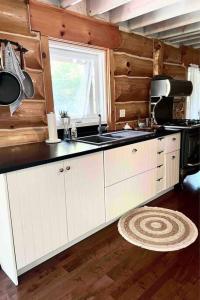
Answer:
[49,41,107,127]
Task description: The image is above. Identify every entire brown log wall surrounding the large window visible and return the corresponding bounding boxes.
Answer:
[0,0,200,146]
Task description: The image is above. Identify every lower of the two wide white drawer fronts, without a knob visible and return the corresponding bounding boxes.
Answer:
[105,169,156,221]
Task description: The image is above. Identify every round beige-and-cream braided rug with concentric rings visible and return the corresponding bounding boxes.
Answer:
[118,206,198,251]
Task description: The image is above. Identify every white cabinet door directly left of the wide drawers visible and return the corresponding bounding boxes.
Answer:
[65,152,105,241]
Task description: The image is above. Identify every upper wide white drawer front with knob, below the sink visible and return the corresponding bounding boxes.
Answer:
[104,139,157,186]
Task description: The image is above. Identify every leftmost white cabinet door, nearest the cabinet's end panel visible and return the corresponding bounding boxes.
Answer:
[7,162,68,269]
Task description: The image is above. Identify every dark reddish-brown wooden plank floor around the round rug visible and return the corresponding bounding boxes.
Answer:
[0,173,200,300]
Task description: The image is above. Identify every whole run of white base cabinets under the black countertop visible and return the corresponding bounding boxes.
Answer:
[0,134,180,284]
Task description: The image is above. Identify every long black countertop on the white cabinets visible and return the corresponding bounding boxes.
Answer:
[0,130,179,174]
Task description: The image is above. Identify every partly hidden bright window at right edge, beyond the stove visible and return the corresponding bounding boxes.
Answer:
[186,65,200,119]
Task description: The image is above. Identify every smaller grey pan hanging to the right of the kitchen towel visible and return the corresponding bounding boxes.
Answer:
[20,48,34,98]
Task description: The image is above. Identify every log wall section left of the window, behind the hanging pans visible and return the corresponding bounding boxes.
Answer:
[0,0,47,147]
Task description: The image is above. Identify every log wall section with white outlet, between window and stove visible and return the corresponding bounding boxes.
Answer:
[110,32,153,129]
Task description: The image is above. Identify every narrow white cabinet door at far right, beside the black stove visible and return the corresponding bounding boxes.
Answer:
[166,150,180,189]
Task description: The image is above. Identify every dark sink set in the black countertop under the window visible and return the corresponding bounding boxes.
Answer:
[77,130,154,145]
